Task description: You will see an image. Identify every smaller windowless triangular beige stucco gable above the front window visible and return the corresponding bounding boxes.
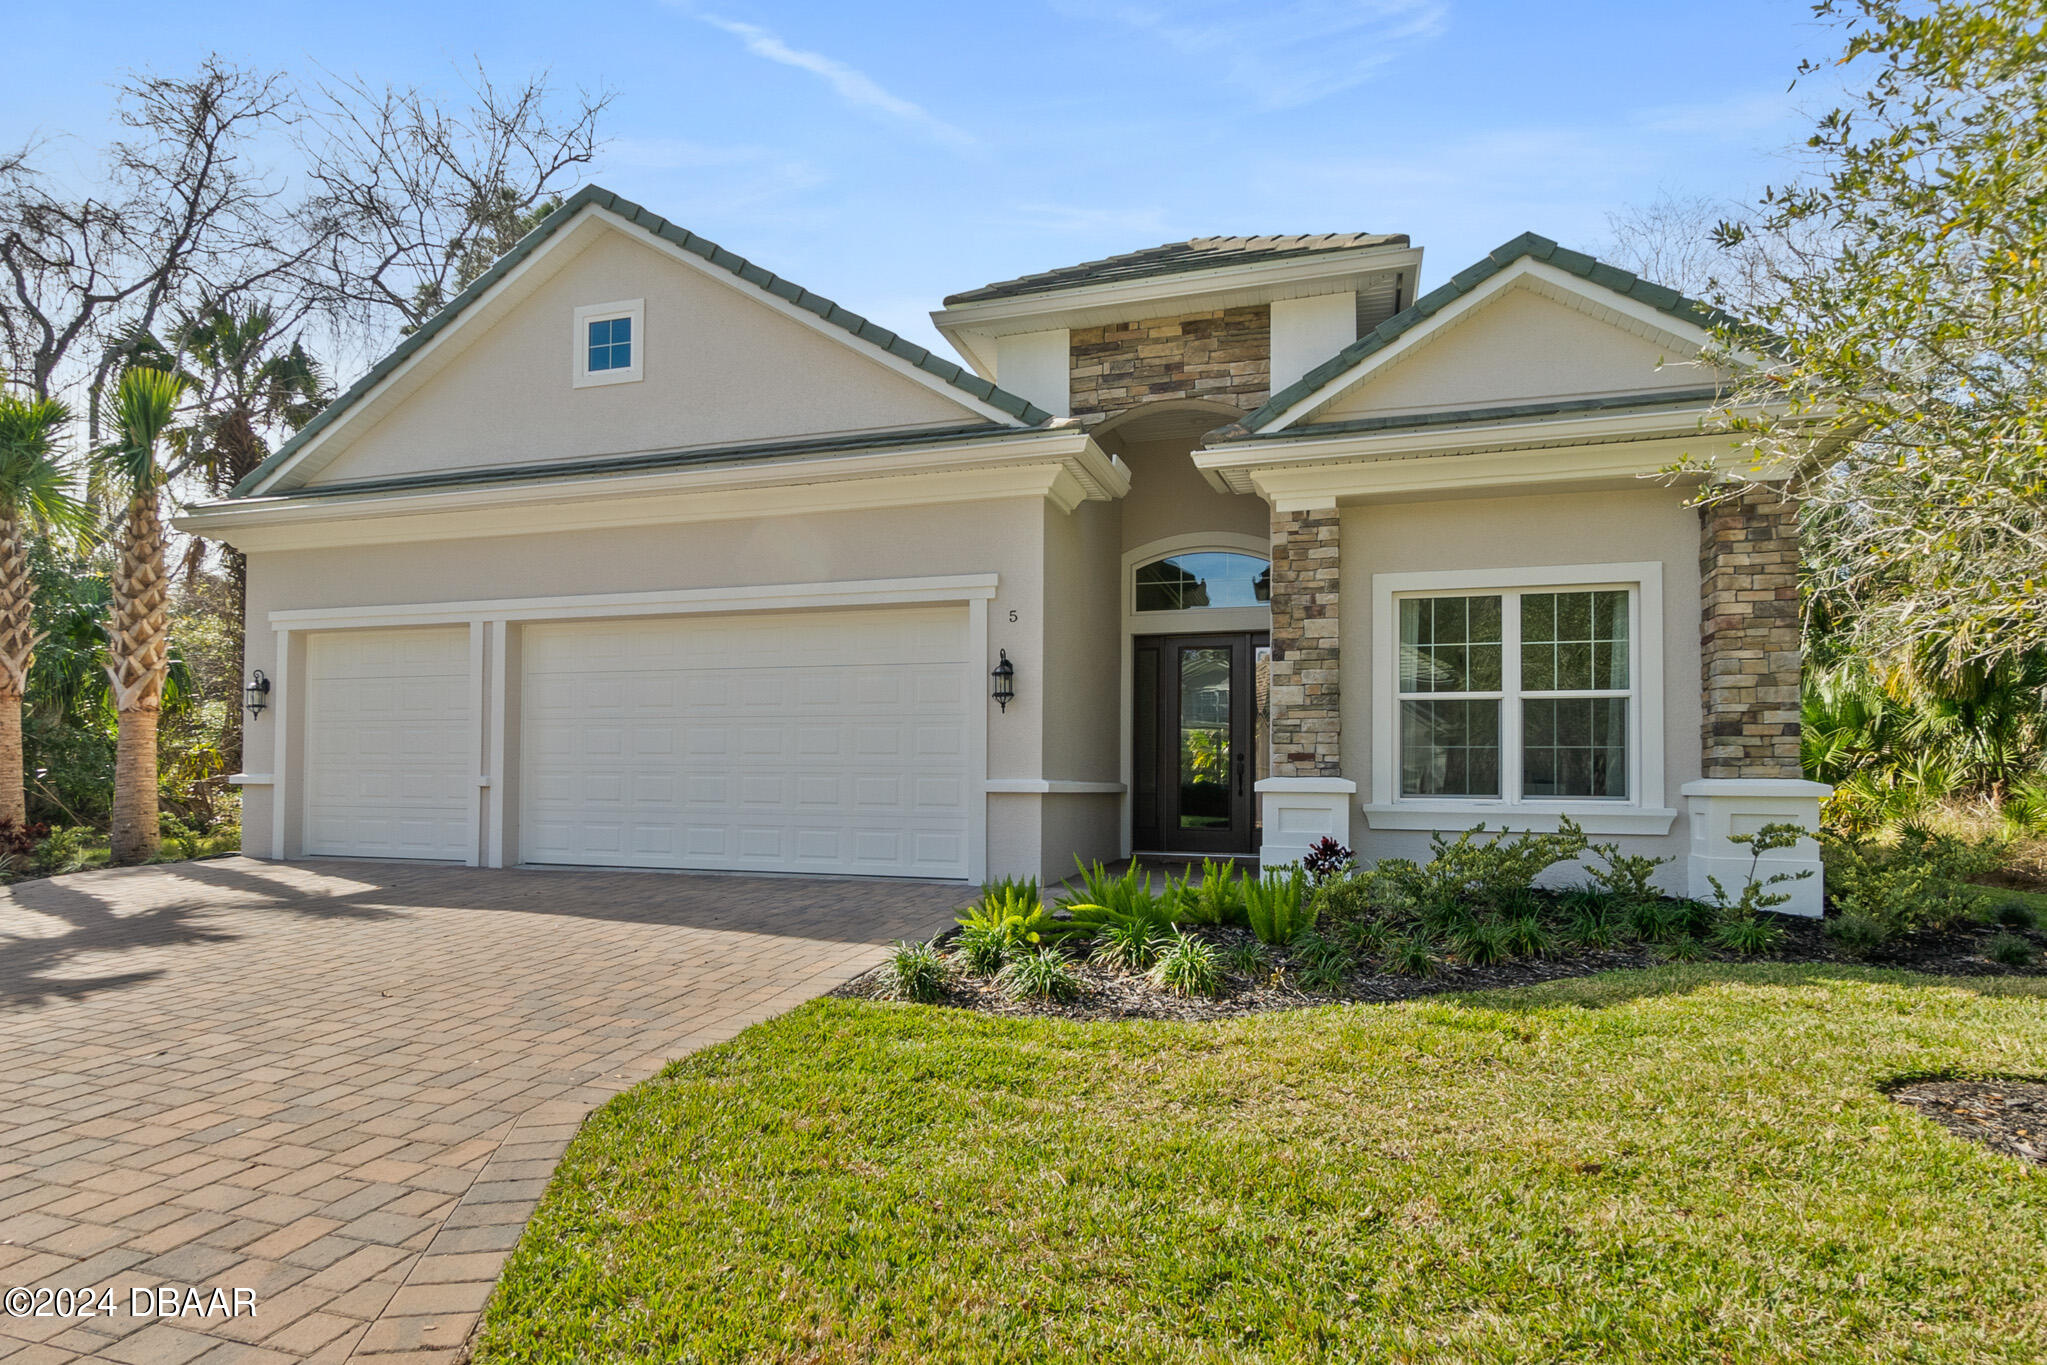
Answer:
[1314,287,1713,422]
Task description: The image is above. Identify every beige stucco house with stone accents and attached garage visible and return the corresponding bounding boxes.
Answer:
[178,188,1826,911]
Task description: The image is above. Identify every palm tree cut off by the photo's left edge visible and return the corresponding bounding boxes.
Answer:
[0,393,82,831]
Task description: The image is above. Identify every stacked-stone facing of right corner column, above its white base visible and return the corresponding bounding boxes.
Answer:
[1694,485,1803,778]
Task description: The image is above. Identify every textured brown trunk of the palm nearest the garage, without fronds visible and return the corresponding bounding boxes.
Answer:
[106,489,170,864]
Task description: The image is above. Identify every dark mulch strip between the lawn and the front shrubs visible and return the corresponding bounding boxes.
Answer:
[831,917,2047,1021]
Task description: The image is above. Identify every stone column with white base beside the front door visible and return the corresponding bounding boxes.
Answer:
[1259,508,1357,868]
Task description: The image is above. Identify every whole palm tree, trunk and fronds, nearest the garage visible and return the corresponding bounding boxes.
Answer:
[94,368,186,864]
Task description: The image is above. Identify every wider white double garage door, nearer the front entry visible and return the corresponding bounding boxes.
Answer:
[520,608,968,878]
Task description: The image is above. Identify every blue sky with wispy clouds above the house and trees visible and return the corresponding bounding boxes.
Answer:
[0,0,1836,360]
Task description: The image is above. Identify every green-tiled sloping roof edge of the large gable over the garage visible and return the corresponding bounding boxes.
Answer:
[227,184,1052,497]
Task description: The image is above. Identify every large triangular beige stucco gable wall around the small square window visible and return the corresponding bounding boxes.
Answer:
[294,231,987,485]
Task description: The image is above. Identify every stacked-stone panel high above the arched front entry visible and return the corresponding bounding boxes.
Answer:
[1069,303,1273,426]
